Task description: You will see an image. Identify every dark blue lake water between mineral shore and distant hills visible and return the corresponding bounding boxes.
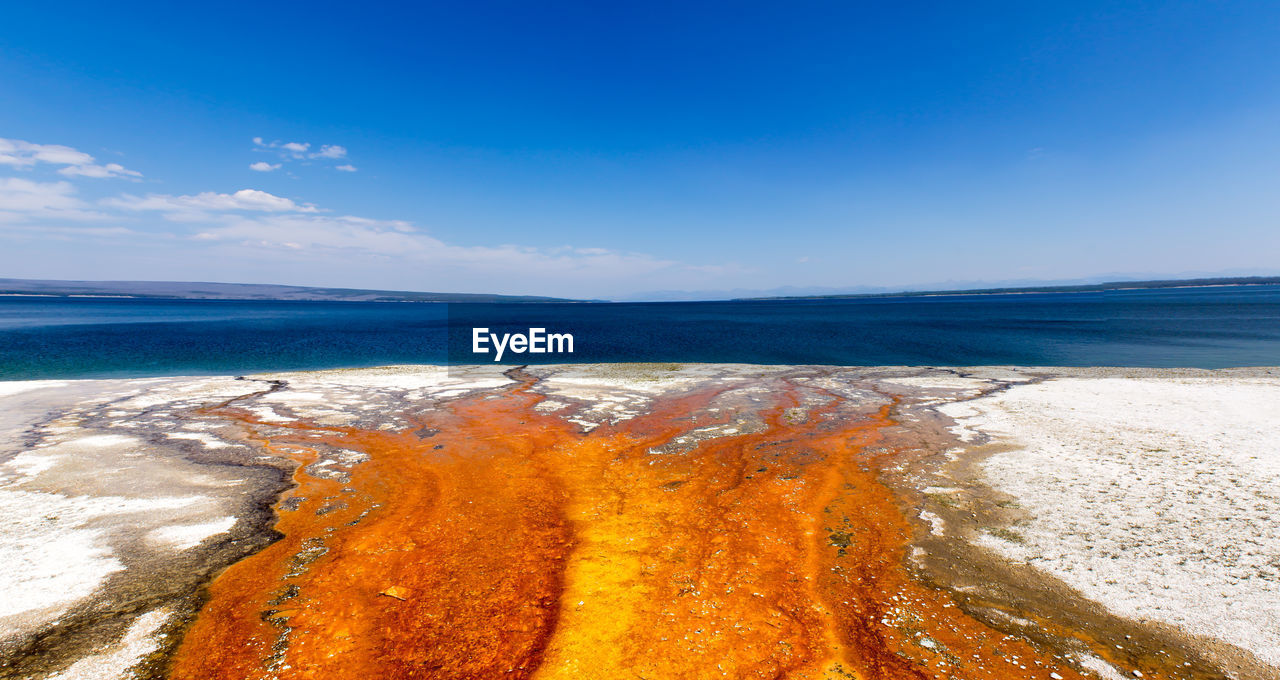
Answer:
[0,286,1280,380]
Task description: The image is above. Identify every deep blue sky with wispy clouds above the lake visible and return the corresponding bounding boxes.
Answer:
[0,1,1280,297]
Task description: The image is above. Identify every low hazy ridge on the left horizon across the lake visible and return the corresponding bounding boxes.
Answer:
[0,279,573,302]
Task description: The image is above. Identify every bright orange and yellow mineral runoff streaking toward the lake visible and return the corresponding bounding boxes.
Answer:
[162,379,1141,679]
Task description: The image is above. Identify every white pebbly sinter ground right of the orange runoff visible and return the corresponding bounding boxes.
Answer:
[942,373,1280,665]
